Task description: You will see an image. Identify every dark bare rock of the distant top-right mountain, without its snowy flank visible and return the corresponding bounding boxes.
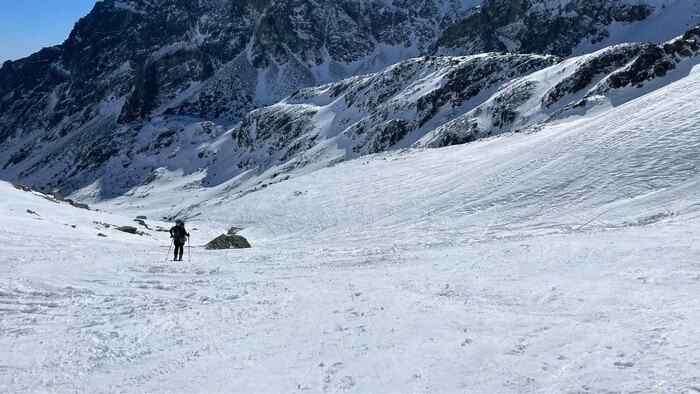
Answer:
[432,0,656,57]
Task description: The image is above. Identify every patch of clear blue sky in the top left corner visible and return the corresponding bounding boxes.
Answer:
[0,0,97,64]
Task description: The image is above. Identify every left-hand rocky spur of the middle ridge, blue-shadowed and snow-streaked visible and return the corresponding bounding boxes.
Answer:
[205,54,558,189]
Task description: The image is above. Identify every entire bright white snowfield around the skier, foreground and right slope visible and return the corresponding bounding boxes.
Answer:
[0,69,700,393]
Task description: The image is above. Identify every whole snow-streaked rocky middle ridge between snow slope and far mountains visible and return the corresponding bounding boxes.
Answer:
[216,27,700,191]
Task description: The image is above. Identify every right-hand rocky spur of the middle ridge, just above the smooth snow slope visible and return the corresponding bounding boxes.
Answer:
[414,26,700,147]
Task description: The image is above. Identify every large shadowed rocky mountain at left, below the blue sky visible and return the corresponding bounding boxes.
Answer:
[0,0,471,194]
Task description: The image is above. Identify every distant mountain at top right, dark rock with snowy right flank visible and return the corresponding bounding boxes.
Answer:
[431,0,700,57]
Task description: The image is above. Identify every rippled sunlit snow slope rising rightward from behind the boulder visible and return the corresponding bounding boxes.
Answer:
[224,67,700,246]
